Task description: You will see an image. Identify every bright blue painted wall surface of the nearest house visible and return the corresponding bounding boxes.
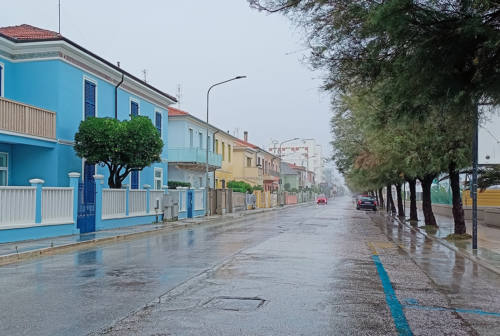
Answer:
[0,57,168,186]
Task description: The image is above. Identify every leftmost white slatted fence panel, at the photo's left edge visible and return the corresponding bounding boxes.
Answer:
[0,187,36,227]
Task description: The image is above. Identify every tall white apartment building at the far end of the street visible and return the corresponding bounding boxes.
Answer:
[267,139,323,184]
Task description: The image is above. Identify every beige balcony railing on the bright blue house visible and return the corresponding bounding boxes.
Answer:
[0,97,56,139]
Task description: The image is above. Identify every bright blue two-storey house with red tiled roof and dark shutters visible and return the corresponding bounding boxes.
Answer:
[0,25,176,189]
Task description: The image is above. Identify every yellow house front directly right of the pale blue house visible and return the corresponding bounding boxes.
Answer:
[214,130,236,189]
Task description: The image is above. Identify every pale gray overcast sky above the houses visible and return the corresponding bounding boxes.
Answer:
[0,0,330,156]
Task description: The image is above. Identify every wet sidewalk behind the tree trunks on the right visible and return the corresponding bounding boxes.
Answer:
[404,208,500,274]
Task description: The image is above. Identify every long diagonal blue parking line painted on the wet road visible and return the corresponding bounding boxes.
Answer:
[372,254,413,336]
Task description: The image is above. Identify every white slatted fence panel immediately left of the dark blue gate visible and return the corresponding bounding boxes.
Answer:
[42,187,74,223]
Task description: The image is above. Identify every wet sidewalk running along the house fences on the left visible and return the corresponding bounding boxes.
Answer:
[0,203,311,265]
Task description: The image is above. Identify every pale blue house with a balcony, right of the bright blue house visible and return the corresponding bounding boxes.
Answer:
[168,107,222,188]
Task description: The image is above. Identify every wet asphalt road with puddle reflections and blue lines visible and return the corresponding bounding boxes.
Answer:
[0,198,500,335]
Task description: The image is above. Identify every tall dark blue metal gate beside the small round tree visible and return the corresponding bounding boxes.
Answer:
[76,180,96,233]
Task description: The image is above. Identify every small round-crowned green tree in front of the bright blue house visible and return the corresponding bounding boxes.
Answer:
[75,116,163,188]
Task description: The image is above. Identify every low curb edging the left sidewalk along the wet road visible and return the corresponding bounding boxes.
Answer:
[0,202,313,266]
